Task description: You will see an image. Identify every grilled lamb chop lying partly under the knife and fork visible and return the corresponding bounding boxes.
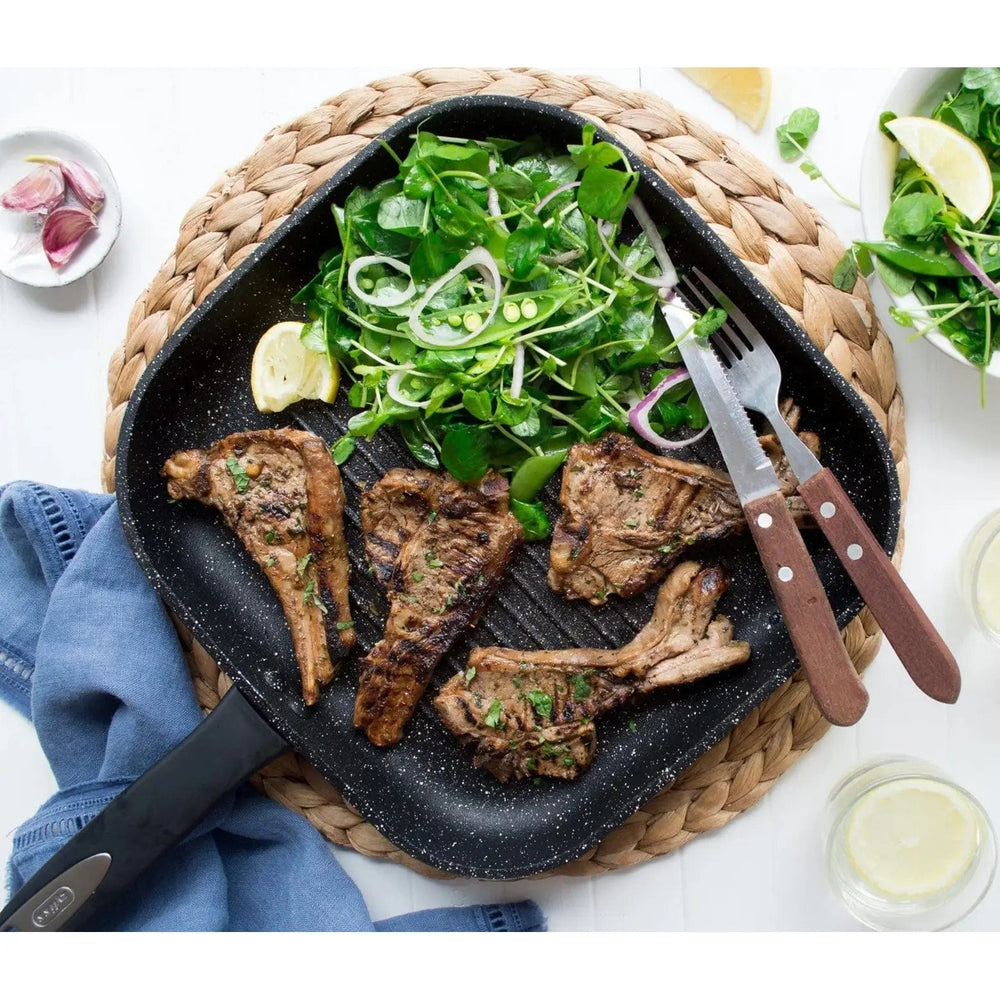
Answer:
[549,405,819,604]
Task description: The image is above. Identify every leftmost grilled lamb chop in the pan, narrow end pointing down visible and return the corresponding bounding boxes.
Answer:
[163,429,355,705]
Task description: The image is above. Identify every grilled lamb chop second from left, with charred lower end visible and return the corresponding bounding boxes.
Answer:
[354,469,523,746]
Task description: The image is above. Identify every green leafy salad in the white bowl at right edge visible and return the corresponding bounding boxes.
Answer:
[834,69,1000,385]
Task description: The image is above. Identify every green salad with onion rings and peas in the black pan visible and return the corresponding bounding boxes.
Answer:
[294,125,719,538]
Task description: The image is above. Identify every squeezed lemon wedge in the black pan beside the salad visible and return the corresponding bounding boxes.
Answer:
[250,321,340,413]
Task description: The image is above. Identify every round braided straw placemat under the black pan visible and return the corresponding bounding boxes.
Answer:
[102,69,908,875]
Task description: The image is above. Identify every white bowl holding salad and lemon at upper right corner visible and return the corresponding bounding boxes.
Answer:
[861,68,1000,377]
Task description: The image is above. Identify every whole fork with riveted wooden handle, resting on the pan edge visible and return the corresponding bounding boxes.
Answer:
[682,269,961,703]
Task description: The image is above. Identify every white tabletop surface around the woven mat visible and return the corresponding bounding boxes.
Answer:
[0,66,1000,930]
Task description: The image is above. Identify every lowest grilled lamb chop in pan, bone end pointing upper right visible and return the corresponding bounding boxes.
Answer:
[434,562,750,781]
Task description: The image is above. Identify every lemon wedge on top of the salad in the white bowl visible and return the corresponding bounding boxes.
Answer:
[885,117,993,222]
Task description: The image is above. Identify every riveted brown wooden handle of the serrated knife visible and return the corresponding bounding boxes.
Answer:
[743,493,868,726]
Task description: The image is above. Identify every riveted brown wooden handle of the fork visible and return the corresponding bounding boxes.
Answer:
[799,469,962,704]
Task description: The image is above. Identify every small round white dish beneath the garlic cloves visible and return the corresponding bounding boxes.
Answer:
[0,129,122,288]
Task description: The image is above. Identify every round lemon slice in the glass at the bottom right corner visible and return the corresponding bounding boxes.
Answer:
[846,778,978,899]
